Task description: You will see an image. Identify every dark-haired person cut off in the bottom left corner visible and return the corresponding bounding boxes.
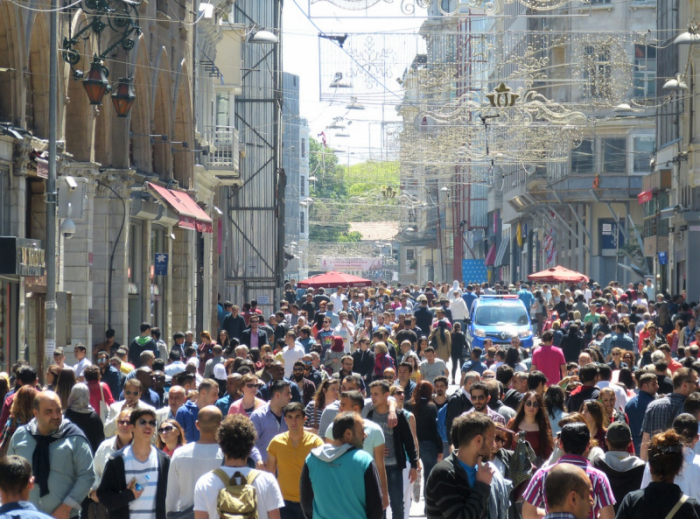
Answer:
[0,456,58,519]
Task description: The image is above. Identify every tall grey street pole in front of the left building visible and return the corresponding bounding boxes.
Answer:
[45,0,58,366]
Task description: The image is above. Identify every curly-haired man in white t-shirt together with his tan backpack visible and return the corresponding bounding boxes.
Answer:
[194,415,284,519]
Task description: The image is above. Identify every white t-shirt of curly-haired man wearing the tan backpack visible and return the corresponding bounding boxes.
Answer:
[194,467,284,519]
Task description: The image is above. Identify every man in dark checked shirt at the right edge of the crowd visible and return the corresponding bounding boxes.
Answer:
[639,368,698,461]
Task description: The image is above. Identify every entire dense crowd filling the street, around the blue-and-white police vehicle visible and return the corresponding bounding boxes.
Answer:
[0,280,700,519]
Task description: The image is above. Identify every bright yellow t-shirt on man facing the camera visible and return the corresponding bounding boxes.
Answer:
[267,432,323,503]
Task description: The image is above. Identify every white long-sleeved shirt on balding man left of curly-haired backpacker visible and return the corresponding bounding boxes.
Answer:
[165,443,224,513]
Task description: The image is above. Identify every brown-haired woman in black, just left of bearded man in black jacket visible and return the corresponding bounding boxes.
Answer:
[405,380,442,494]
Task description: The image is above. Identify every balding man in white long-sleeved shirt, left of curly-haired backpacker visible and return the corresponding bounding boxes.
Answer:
[165,405,224,513]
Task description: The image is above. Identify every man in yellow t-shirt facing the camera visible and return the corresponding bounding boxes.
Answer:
[265,402,323,519]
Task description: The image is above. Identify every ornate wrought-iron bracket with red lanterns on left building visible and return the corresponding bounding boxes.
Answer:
[61,0,142,117]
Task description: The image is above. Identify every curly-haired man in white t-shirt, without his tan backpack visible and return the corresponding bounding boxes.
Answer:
[194,415,284,519]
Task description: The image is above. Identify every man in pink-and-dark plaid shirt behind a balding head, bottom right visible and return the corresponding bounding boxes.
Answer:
[523,423,615,519]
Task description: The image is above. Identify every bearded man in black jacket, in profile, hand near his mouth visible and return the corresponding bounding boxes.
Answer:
[425,413,500,519]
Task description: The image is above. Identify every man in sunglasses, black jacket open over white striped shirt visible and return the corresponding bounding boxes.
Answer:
[97,408,170,519]
